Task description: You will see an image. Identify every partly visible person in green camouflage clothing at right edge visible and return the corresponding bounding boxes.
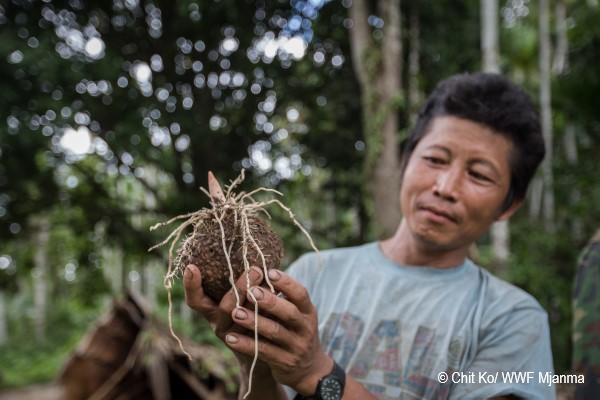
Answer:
[572,230,600,400]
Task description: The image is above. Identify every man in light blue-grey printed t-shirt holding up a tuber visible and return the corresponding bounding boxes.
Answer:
[184,74,555,400]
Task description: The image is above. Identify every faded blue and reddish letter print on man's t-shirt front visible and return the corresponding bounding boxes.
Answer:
[321,313,454,400]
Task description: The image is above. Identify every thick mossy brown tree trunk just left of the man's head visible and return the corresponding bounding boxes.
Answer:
[349,0,402,236]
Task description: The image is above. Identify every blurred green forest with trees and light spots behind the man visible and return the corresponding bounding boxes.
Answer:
[0,0,600,387]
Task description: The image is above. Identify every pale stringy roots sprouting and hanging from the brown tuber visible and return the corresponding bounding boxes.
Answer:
[149,169,321,398]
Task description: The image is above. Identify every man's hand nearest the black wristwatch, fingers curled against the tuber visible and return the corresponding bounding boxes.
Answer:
[225,270,333,396]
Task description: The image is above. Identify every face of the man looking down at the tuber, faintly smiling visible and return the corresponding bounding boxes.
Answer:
[400,116,519,251]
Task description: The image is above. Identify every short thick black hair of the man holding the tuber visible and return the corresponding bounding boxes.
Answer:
[401,73,546,211]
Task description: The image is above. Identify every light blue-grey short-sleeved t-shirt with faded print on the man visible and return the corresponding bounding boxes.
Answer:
[286,243,555,399]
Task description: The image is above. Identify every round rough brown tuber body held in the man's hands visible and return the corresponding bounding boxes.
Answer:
[177,212,283,303]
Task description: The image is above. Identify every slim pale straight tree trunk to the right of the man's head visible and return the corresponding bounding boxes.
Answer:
[539,0,555,232]
